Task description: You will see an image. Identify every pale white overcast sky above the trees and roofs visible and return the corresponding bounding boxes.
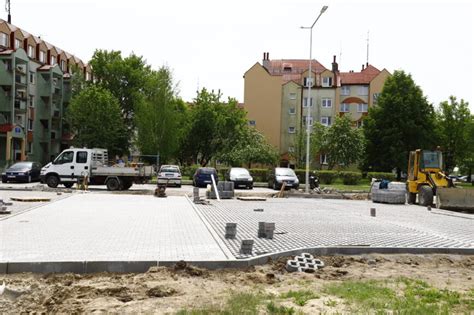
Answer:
[4,0,474,111]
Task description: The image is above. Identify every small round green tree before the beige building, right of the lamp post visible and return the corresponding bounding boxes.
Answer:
[321,116,364,168]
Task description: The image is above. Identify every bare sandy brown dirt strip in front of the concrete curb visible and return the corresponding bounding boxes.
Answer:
[0,255,474,314]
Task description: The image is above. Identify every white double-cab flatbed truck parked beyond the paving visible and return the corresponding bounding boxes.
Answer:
[41,148,153,191]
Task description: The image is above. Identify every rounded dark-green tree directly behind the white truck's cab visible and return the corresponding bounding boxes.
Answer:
[66,86,128,156]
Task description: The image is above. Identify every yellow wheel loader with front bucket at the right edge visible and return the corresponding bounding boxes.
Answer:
[407,150,474,211]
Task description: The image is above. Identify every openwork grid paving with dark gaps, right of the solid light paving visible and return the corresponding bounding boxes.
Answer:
[193,199,474,258]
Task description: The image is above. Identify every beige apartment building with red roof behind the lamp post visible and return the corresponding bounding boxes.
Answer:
[244,53,390,165]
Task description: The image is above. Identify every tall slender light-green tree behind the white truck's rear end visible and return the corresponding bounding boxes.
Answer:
[135,67,184,161]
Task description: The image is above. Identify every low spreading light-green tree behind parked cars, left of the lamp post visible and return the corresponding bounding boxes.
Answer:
[218,126,278,168]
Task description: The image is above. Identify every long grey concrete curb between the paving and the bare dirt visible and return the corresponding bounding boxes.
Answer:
[0,246,474,274]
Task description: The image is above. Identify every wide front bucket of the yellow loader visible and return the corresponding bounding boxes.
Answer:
[436,187,474,212]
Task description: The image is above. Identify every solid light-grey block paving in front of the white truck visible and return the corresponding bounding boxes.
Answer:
[0,194,227,262]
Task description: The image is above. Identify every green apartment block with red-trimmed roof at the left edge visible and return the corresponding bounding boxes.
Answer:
[0,19,91,167]
